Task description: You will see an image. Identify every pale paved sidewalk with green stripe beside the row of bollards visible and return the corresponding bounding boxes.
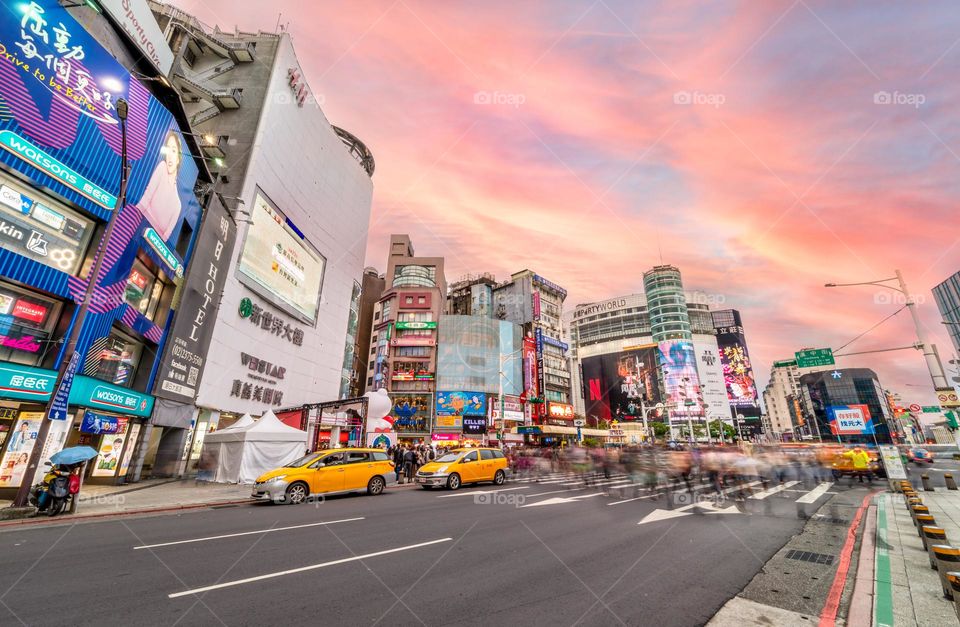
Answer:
[861,488,960,627]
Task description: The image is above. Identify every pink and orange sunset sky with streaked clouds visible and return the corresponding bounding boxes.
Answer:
[176,0,960,402]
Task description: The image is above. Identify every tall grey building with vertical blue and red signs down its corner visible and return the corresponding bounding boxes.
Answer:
[493,270,574,426]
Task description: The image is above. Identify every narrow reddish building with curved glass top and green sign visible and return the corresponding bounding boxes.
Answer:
[367,235,447,442]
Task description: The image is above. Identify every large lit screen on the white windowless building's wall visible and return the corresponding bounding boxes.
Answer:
[237,189,327,324]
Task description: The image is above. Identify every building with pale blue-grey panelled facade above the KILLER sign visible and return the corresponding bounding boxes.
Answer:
[432,315,524,444]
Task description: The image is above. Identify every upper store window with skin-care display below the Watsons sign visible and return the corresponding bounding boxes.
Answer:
[0,174,94,275]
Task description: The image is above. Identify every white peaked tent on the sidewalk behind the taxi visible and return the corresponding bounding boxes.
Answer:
[199,411,307,483]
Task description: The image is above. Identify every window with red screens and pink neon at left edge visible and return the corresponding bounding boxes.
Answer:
[0,282,61,366]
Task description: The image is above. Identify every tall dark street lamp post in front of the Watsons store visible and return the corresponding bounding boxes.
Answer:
[13,98,130,507]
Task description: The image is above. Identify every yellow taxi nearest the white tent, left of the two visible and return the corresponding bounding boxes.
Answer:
[250,448,396,505]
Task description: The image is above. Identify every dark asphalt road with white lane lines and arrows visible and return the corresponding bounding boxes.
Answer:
[0,478,865,625]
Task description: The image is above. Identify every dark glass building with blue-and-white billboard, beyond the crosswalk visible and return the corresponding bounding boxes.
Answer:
[800,368,896,444]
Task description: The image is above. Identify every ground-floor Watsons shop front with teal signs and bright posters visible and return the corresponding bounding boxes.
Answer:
[0,362,153,498]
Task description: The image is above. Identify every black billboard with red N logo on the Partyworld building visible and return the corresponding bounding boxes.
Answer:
[581,344,662,420]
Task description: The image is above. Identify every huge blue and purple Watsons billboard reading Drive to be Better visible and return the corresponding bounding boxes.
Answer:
[0,0,200,288]
